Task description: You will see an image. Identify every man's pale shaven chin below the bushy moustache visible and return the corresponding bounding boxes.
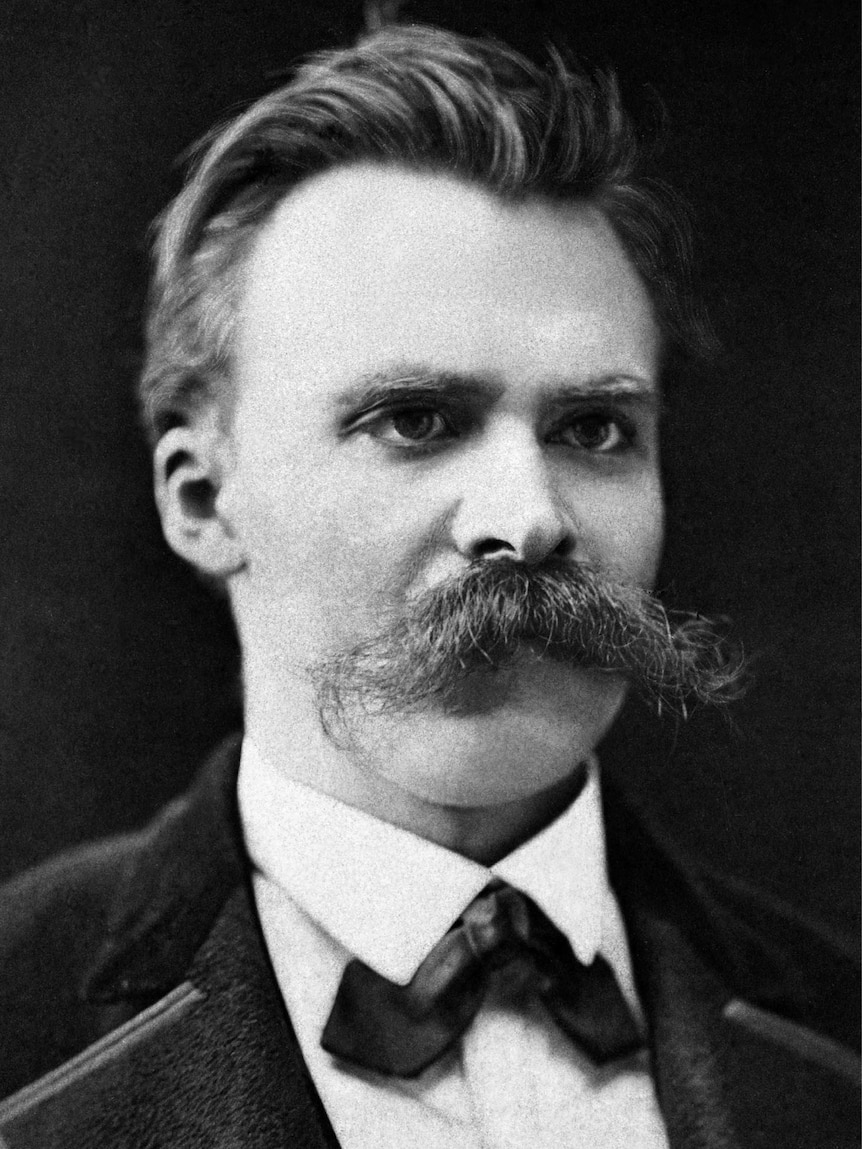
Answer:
[363,660,625,808]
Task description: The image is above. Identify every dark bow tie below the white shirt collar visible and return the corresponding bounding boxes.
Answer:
[321,881,642,1077]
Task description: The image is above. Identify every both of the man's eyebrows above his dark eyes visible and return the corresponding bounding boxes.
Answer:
[336,367,659,411]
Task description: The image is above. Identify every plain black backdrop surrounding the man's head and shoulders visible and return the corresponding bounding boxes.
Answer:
[0,0,859,931]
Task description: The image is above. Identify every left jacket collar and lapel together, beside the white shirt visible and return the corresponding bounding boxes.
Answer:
[0,746,338,1149]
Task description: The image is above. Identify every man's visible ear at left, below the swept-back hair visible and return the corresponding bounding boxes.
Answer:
[153,410,245,579]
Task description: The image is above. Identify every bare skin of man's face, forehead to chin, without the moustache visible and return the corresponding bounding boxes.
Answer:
[221,165,662,804]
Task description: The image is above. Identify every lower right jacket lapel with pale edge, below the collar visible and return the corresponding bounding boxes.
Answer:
[636,900,860,1149]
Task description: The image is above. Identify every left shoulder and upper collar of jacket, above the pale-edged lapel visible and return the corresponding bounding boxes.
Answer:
[0,737,246,1097]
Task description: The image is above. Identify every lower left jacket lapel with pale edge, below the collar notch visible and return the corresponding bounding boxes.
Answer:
[0,888,337,1149]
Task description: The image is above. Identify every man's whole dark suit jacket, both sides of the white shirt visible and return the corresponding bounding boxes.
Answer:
[0,741,859,1149]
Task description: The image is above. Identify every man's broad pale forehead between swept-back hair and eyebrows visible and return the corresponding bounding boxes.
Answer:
[236,164,659,401]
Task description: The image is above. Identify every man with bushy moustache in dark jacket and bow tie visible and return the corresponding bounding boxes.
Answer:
[0,29,856,1149]
